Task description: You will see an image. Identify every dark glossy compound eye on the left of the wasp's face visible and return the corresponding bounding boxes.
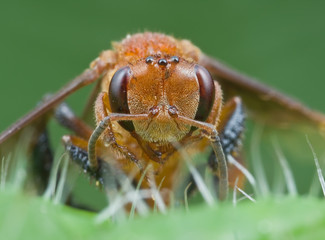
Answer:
[108,67,134,132]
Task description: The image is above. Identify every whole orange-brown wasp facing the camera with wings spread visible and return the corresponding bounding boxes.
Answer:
[0,32,325,203]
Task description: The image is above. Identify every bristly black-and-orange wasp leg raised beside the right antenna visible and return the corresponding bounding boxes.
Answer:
[209,97,245,187]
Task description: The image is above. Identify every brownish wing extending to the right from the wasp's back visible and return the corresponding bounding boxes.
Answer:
[200,55,325,127]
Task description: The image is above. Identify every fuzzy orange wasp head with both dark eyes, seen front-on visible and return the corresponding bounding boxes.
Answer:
[109,56,215,143]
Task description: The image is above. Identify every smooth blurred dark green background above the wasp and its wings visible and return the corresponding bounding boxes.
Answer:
[0,0,325,133]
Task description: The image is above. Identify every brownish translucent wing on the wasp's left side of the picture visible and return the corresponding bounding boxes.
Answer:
[0,61,107,184]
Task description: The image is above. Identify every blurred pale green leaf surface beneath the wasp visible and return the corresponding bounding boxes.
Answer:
[0,192,325,240]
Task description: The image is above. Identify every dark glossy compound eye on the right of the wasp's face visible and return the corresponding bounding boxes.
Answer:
[195,65,215,122]
